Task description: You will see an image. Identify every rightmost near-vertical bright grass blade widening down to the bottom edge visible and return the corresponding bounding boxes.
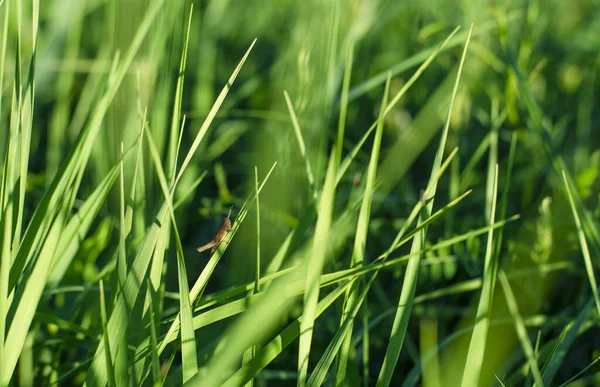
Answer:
[462,165,498,387]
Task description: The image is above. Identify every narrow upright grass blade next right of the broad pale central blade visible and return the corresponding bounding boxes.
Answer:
[335,74,392,385]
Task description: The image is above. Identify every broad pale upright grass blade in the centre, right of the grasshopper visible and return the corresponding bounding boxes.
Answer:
[298,153,336,387]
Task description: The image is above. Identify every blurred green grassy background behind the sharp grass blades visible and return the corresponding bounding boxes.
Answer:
[0,0,600,386]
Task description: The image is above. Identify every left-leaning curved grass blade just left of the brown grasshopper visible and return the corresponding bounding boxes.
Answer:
[146,127,198,383]
